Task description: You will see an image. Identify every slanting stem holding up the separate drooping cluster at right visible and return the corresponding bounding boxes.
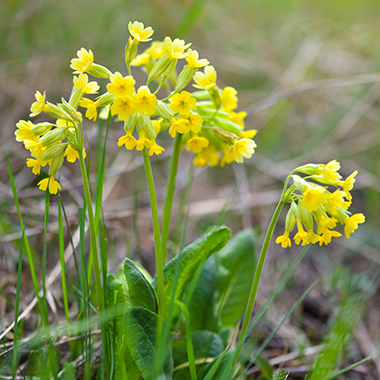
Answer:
[233,197,285,367]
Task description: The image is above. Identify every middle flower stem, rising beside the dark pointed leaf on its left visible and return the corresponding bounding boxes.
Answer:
[142,147,166,320]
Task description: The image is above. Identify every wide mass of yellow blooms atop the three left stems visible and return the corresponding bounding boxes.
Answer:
[15,21,256,194]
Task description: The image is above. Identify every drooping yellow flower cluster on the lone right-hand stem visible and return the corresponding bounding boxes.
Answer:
[276,160,365,248]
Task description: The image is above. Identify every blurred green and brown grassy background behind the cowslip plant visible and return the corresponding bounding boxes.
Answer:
[0,0,380,379]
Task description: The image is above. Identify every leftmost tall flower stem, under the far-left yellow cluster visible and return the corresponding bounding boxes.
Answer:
[78,150,109,378]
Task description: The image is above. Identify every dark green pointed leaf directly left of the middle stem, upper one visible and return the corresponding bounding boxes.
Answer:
[124,258,157,313]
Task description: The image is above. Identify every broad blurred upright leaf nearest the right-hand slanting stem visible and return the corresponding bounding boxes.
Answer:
[218,229,257,326]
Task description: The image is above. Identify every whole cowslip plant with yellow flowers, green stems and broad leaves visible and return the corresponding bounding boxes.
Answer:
[9,21,364,380]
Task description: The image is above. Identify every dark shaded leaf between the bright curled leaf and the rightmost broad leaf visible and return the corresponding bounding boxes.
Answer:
[188,256,216,331]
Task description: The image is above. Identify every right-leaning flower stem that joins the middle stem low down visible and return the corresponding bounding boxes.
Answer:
[161,133,182,265]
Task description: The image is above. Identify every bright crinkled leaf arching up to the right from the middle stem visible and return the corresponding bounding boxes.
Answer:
[152,227,231,321]
